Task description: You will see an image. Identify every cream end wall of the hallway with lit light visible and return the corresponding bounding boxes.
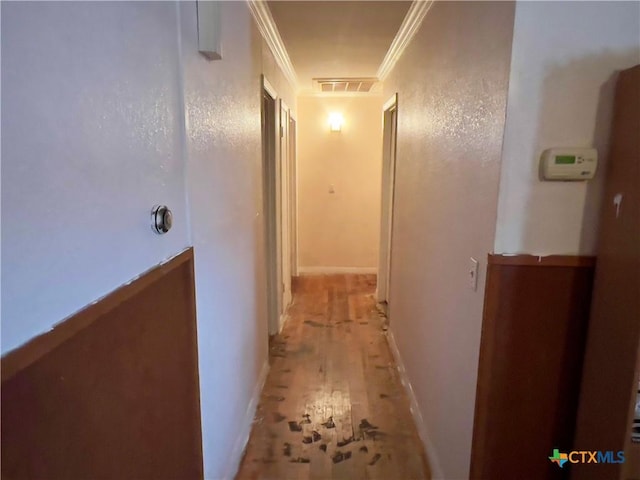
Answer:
[298,97,382,272]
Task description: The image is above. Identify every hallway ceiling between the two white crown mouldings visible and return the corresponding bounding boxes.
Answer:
[268,0,411,92]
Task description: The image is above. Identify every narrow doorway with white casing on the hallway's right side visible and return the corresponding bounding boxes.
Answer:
[376,93,398,316]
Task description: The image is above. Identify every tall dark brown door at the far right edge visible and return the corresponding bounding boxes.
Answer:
[571,65,640,480]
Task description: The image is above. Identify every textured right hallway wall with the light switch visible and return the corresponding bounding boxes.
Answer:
[385,2,514,479]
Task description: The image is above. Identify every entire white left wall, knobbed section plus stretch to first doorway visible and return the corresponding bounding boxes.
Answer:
[1,2,295,479]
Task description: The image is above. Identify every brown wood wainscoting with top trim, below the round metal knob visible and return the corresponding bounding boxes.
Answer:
[1,249,203,480]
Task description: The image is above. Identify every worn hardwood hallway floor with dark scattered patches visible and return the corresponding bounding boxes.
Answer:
[236,275,429,480]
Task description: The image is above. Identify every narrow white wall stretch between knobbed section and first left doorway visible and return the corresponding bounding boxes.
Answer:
[180,2,294,479]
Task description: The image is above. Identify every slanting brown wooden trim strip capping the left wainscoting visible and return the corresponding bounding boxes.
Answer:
[0,247,194,383]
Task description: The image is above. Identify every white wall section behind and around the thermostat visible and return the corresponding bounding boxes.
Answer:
[495,2,640,255]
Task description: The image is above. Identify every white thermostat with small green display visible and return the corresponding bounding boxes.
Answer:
[540,148,598,180]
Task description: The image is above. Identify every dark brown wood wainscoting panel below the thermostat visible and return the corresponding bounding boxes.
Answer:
[471,255,595,480]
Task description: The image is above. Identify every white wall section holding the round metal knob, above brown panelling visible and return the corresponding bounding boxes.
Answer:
[2,2,189,353]
